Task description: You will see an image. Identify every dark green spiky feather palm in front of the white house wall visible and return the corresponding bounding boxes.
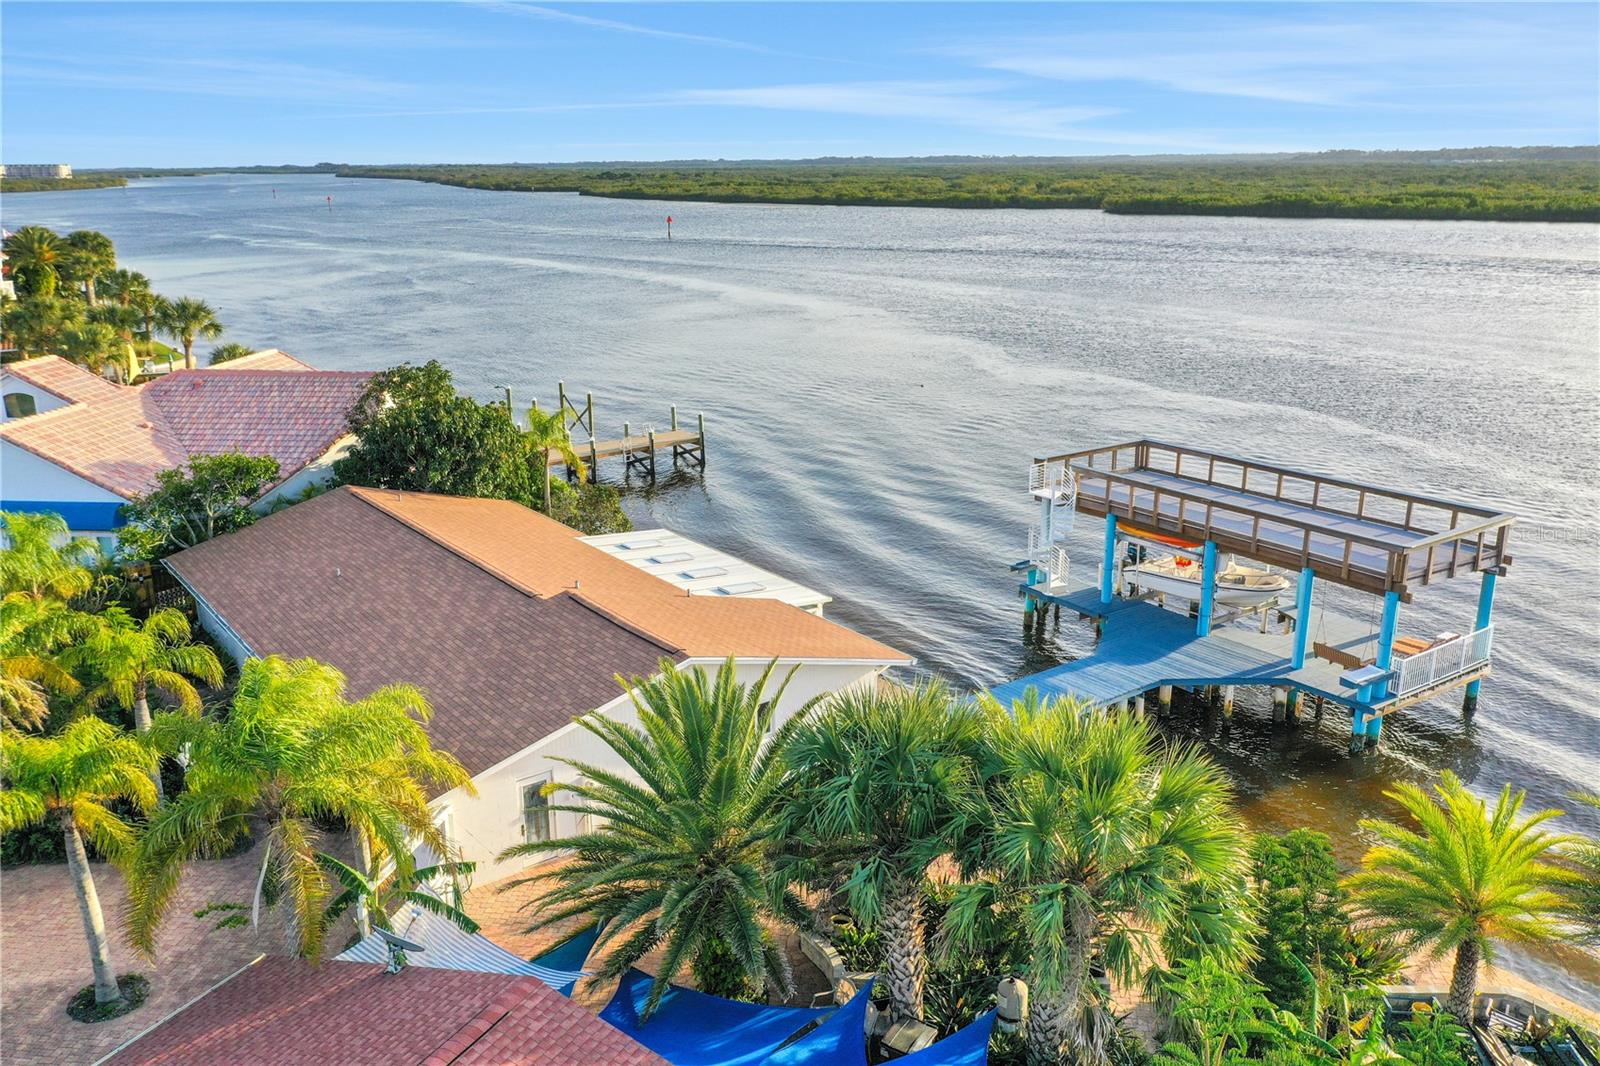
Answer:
[501,659,802,1016]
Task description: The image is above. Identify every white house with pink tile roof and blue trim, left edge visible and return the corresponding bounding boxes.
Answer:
[0,349,371,547]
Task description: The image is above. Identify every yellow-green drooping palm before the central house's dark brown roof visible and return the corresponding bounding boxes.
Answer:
[128,656,470,960]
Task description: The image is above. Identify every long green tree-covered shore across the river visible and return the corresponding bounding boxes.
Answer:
[339,157,1600,222]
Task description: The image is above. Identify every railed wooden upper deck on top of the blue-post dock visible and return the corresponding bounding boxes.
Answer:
[1035,440,1515,595]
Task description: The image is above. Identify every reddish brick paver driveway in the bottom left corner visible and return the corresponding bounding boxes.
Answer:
[0,850,285,1066]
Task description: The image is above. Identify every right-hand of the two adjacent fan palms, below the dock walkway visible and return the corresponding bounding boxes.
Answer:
[944,695,1246,1066]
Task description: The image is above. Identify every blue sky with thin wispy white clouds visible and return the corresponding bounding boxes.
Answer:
[0,0,1600,166]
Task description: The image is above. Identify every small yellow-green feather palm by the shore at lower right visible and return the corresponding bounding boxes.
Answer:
[1346,770,1576,1021]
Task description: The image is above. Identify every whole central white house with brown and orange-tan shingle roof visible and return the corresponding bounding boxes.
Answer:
[166,487,910,880]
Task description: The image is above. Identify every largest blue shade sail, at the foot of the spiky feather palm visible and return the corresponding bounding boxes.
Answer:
[600,970,838,1066]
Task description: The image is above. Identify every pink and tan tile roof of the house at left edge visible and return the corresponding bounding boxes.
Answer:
[0,351,371,496]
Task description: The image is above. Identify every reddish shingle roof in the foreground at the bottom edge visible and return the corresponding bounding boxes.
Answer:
[107,959,666,1066]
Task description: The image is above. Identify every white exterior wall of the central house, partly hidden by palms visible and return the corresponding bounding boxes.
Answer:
[434,663,883,885]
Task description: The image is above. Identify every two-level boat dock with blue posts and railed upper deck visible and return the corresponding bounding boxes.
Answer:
[994,439,1515,751]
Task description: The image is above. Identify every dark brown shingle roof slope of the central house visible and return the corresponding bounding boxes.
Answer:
[157,488,668,773]
